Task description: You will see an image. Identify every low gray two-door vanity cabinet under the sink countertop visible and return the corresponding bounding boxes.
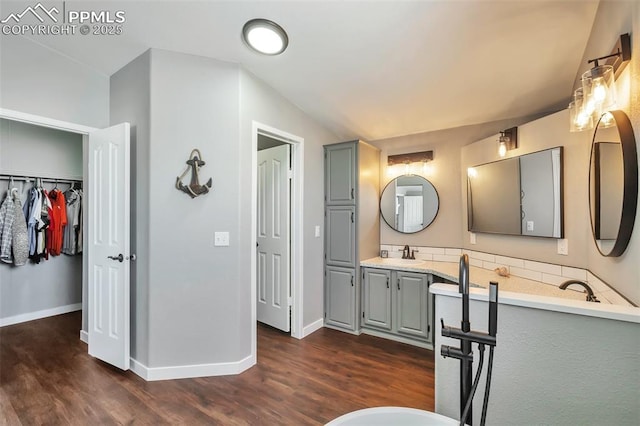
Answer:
[361,267,433,348]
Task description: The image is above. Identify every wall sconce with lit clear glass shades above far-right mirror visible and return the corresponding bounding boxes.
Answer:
[569,34,631,132]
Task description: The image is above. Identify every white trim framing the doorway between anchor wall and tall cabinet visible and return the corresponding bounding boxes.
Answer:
[251,121,304,344]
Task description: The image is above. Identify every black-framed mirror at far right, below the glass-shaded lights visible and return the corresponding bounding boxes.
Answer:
[589,111,638,257]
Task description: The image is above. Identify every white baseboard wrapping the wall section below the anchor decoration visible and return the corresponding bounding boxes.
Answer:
[130,355,256,382]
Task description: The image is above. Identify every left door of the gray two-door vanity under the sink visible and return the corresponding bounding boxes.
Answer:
[362,268,391,330]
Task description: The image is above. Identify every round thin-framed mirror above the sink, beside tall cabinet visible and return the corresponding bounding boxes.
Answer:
[380,175,439,234]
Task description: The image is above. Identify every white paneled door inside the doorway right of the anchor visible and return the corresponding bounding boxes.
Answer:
[257,144,291,332]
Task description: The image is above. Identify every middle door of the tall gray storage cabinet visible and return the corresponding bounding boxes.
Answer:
[325,206,356,268]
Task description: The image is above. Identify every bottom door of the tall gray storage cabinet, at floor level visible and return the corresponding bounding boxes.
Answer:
[325,266,356,330]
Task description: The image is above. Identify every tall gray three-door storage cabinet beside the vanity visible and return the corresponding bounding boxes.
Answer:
[324,141,380,333]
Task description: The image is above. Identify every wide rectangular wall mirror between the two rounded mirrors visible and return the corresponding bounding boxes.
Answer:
[467,147,563,238]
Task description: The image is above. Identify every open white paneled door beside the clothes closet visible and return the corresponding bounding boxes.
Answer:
[85,123,130,370]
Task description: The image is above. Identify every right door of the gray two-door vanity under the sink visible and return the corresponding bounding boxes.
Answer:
[396,271,429,339]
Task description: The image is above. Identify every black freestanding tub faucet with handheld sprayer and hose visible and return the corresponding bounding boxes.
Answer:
[440,254,498,425]
